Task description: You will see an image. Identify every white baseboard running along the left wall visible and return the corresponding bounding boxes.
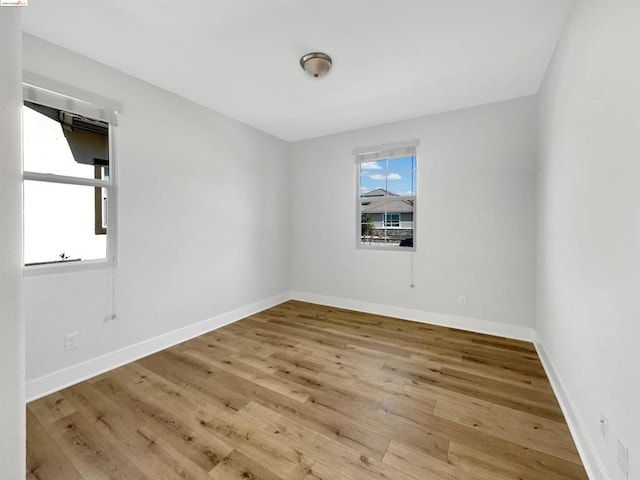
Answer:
[26,292,291,402]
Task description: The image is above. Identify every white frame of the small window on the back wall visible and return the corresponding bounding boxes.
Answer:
[353,139,419,252]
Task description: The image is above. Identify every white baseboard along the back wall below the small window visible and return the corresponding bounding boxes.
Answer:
[291,292,536,342]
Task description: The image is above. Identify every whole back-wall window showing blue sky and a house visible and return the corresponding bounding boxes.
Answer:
[354,140,418,251]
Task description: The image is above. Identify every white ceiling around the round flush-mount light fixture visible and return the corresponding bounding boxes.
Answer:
[23,0,573,141]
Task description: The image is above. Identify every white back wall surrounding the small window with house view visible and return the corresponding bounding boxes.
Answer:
[292,97,536,337]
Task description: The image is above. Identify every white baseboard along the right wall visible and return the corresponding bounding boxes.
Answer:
[535,340,609,480]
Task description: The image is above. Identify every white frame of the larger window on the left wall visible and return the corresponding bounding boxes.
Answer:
[22,77,118,277]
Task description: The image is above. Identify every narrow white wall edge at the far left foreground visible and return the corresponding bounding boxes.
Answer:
[0,8,25,478]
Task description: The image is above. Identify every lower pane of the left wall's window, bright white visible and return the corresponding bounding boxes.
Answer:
[24,182,107,265]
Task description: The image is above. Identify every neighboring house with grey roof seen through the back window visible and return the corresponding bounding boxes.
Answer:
[360,188,414,239]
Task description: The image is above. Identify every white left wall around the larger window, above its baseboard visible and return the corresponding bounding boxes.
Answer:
[23,35,290,396]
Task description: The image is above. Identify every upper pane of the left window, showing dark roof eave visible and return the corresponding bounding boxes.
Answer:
[22,102,109,178]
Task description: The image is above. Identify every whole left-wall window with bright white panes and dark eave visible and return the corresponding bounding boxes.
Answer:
[23,80,115,272]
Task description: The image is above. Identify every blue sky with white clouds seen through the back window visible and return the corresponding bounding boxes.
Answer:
[360,156,416,195]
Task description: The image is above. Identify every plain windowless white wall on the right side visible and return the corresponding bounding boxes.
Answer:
[537,1,640,480]
